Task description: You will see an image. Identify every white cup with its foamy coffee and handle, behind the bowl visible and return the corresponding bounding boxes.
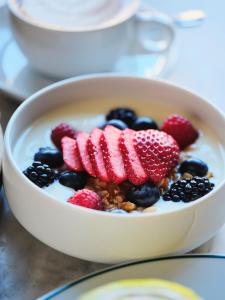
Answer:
[7,0,174,78]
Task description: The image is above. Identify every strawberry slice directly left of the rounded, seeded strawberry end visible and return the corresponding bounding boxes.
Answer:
[119,129,148,185]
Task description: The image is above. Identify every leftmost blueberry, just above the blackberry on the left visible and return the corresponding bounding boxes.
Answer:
[34,147,64,168]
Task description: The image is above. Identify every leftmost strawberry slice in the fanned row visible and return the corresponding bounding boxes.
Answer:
[61,136,83,171]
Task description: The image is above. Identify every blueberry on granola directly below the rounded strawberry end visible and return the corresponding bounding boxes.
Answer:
[126,183,160,207]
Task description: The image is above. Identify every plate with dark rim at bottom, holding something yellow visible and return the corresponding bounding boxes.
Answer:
[38,255,225,300]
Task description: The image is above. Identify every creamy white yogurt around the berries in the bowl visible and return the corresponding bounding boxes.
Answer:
[13,99,225,212]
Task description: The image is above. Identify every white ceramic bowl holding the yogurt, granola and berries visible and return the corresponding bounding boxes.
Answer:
[3,75,225,263]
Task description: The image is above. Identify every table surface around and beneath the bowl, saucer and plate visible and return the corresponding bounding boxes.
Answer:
[0,0,225,300]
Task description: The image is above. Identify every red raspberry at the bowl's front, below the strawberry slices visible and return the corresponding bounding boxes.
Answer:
[68,189,103,210]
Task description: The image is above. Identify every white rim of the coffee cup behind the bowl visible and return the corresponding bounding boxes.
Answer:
[6,0,140,33]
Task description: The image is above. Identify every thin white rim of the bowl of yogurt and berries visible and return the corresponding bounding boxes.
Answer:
[3,73,225,219]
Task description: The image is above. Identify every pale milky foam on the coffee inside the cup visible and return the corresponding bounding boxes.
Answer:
[11,0,133,29]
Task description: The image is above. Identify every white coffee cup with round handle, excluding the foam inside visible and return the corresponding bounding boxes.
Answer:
[7,0,174,78]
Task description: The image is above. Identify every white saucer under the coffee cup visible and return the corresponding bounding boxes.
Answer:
[0,5,176,102]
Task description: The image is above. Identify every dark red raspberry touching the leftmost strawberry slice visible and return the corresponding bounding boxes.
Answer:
[51,123,77,149]
